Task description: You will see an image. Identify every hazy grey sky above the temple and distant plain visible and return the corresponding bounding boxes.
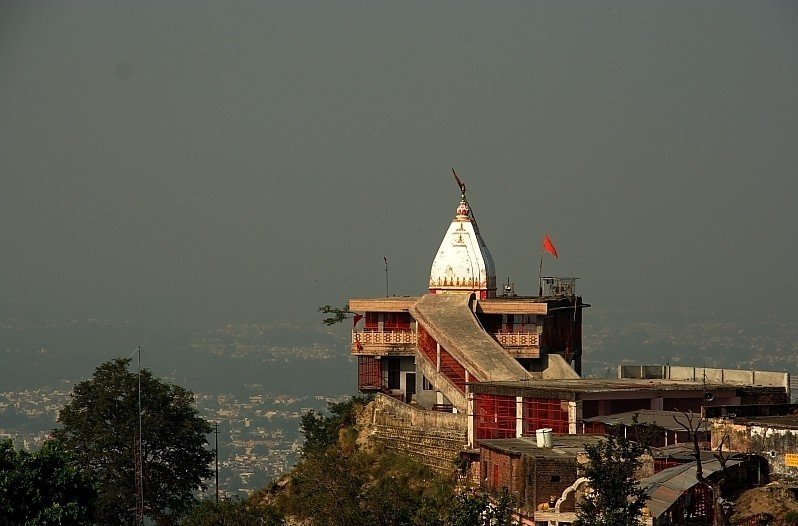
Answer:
[0,0,798,326]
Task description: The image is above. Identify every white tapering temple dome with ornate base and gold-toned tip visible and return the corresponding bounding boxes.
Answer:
[429,192,496,299]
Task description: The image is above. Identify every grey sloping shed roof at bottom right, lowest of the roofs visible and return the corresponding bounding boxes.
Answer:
[640,459,742,518]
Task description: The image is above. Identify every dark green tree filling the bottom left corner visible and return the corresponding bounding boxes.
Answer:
[0,439,97,526]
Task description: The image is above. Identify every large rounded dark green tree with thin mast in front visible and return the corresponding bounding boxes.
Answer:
[56,358,213,525]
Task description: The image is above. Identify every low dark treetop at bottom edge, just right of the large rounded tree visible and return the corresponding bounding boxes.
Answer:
[180,499,285,526]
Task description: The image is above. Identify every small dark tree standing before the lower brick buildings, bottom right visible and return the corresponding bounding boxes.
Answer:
[574,430,646,526]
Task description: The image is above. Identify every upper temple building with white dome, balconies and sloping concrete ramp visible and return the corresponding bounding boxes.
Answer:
[349,185,588,411]
